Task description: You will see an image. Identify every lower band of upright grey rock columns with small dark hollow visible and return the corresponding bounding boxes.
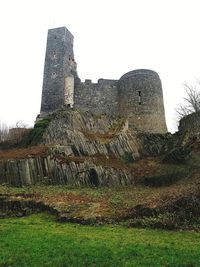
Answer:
[0,152,133,186]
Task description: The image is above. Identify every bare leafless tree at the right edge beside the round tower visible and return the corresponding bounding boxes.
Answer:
[176,80,200,119]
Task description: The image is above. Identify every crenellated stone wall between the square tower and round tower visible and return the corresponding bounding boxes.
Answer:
[74,79,118,116]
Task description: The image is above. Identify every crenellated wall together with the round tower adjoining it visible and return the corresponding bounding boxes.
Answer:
[74,70,167,133]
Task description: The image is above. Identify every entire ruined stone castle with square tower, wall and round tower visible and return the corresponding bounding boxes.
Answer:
[40,27,167,133]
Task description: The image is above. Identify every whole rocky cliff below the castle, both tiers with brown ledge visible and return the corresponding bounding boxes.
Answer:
[0,109,199,187]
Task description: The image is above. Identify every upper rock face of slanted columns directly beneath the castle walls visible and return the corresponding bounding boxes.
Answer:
[43,110,139,158]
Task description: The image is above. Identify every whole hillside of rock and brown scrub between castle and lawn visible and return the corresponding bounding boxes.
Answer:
[0,110,200,229]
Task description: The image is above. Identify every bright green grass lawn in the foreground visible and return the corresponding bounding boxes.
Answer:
[0,214,200,267]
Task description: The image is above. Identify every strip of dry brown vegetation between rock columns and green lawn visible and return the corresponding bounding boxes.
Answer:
[0,161,200,229]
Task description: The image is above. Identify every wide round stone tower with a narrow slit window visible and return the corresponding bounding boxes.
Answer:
[118,69,167,133]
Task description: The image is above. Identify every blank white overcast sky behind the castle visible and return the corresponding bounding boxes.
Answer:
[0,0,200,131]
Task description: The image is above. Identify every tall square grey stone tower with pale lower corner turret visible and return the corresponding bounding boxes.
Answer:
[40,27,77,115]
